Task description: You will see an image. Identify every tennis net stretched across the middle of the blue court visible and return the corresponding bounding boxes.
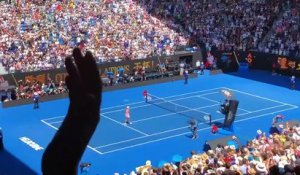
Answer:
[146,94,211,123]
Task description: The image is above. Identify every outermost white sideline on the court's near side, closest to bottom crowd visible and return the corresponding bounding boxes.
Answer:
[96,104,298,154]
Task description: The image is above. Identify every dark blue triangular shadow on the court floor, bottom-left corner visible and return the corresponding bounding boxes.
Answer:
[0,150,37,175]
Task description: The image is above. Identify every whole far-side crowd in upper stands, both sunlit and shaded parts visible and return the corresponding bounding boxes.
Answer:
[0,0,300,72]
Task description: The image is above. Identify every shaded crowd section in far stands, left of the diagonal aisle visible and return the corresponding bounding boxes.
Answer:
[142,0,299,51]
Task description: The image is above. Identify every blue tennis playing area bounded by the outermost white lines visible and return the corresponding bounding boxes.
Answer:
[41,87,297,154]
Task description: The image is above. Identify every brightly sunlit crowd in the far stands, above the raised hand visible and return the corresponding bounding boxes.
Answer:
[0,0,187,72]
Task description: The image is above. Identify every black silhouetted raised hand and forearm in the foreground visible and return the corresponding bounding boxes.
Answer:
[42,48,102,175]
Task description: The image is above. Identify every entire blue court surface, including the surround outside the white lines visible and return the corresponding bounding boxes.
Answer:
[0,71,300,175]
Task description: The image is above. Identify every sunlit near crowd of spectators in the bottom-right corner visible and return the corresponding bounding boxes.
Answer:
[128,122,300,175]
